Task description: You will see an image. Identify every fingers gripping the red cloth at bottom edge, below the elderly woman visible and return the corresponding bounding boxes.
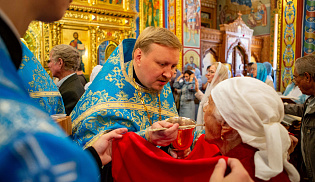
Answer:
[210,158,254,182]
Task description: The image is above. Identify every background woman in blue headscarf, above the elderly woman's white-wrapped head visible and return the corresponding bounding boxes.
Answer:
[250,63,274,88]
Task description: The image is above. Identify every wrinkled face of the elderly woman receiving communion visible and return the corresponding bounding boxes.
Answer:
[203,95,222,143]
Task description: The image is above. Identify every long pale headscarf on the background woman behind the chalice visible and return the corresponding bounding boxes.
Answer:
[196,62,229,130]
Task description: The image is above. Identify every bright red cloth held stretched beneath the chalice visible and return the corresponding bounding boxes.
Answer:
[112,132,223,182]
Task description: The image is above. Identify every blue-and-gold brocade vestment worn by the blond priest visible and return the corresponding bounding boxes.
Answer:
[71,39,178,147]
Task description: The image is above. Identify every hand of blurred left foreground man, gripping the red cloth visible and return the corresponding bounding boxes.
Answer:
[93,128,128,165]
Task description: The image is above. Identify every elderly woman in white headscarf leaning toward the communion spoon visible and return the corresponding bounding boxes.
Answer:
[204,77,299,181]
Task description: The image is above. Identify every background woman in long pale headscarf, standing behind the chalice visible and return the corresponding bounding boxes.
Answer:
[195,62,229,130]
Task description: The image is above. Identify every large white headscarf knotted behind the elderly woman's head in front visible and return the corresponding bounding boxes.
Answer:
[211,77,300,181]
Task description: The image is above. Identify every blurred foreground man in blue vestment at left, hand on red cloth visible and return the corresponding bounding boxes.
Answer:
[0,0,127,182]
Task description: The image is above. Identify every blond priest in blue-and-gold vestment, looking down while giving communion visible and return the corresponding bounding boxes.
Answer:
[71,27,182,148]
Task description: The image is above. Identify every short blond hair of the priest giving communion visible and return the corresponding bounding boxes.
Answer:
[132,27,182,59]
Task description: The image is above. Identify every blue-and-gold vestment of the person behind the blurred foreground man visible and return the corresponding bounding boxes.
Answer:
[18,42,65,115]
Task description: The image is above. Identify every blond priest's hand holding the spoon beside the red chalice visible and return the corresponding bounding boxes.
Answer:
[146,121,179,147]
